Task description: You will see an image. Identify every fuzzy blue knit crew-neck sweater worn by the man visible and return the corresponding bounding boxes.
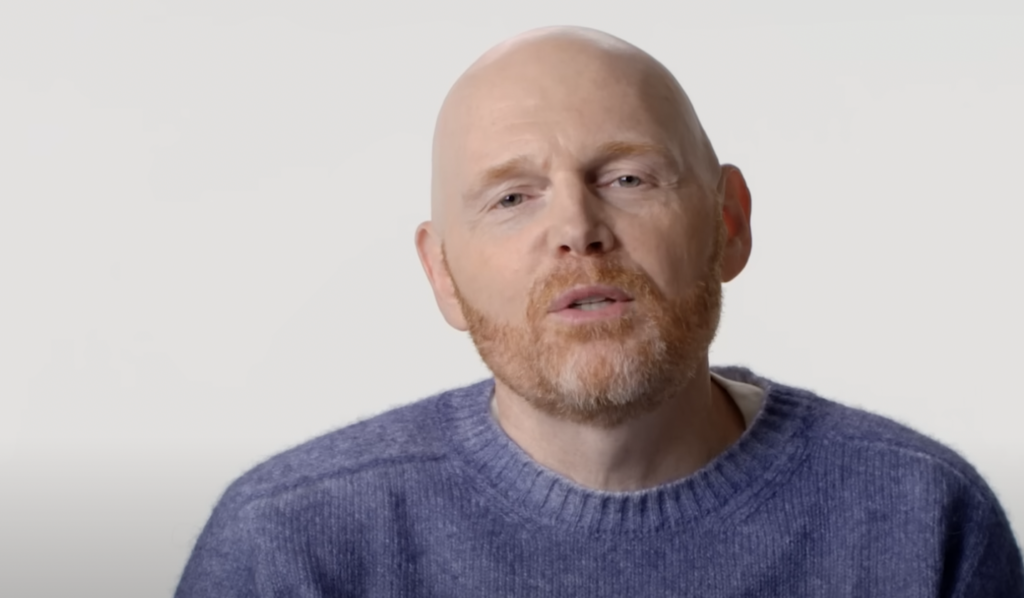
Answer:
[176,368,1024,598]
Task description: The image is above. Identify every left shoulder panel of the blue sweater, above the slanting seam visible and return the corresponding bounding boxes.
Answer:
[221,382,473,508]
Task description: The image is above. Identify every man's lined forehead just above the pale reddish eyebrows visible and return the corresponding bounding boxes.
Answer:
[447,54,679,172]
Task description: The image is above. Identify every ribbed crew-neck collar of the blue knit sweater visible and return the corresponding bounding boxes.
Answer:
[438,367,814,533]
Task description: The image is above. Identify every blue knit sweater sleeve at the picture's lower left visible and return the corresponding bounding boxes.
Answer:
[174,489,259,598]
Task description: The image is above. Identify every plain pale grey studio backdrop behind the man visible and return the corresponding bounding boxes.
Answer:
[0,0,1024,598]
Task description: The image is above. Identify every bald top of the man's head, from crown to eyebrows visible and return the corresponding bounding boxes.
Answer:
[431,27,720,234]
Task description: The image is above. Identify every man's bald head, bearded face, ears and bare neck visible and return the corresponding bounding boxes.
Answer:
[416,28,752,492]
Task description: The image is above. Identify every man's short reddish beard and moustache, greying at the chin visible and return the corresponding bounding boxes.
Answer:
[441,219,725,427]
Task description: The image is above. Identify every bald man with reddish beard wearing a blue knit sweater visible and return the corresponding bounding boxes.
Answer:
[176,28,1024,598]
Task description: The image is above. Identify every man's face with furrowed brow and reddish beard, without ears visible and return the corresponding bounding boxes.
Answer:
[421,40,745,425]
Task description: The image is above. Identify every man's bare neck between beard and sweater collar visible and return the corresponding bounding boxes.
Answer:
[493,365,744,492]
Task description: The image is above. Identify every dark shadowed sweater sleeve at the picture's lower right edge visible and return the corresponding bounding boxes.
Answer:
[951,503,1024,598]
